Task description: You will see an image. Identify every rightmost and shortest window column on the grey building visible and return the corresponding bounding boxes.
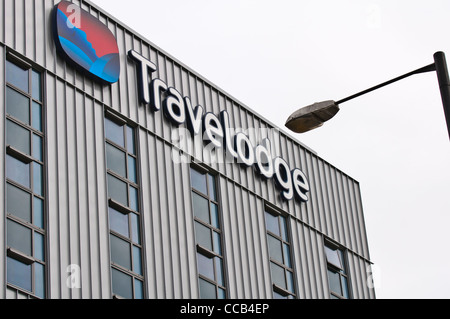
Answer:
[325,242,350,299]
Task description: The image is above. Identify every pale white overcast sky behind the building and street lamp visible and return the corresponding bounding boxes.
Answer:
[91,0,450,298]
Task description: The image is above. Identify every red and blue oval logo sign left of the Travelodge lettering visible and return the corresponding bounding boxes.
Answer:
[54,1,120,84]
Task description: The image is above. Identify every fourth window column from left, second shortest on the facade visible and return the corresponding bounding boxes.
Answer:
[265,210,296,299]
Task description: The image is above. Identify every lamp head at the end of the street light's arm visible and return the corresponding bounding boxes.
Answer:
[285,101,339,133]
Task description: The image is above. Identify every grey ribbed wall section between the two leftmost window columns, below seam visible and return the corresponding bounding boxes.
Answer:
[46,75,110,298]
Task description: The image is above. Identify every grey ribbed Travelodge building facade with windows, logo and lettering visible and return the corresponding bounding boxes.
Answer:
[0,0,375,299]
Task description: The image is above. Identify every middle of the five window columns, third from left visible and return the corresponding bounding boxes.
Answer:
[191,168,227,299]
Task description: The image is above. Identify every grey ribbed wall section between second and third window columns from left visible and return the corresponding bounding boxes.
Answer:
[140,131,201,298]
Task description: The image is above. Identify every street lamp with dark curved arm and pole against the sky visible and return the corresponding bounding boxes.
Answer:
[286,52,450,137]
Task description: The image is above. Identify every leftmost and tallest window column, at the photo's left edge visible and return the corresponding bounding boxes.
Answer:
[5,55,46,298]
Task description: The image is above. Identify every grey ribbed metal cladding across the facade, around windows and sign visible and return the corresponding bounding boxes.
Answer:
[0,0,375,298]
